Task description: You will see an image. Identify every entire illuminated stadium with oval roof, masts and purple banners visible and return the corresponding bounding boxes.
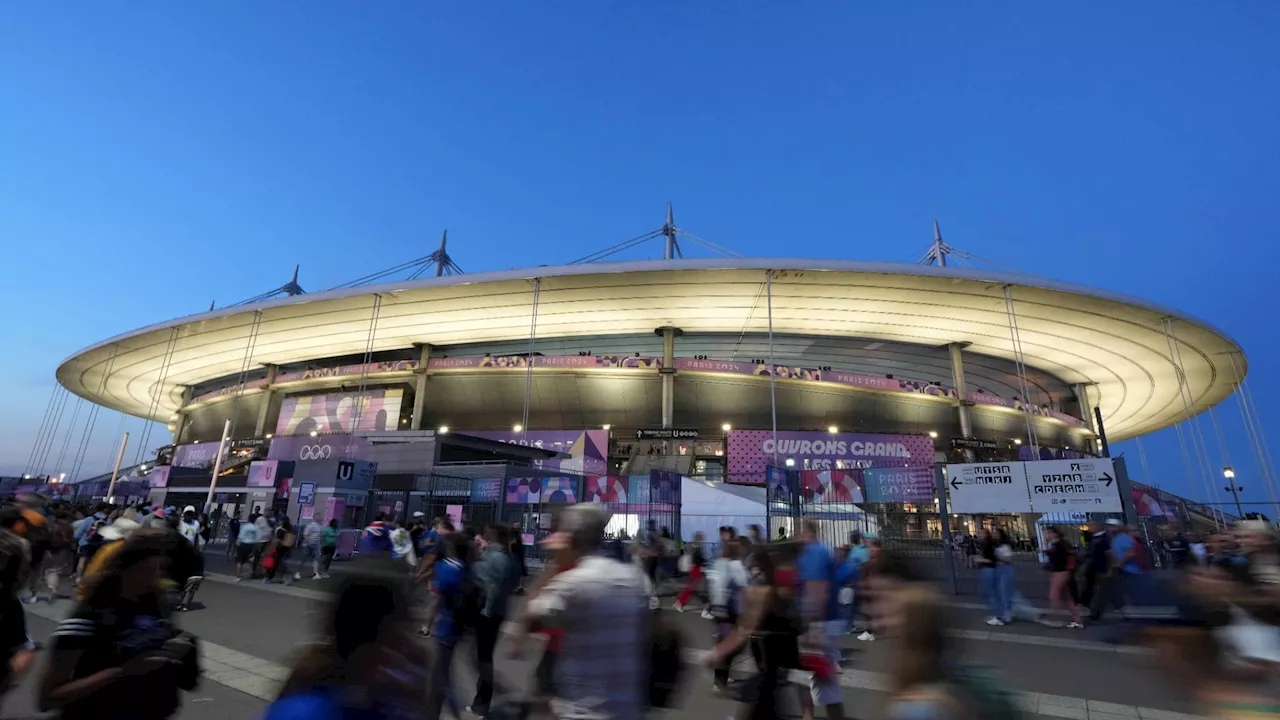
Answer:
[42,217,1247,543]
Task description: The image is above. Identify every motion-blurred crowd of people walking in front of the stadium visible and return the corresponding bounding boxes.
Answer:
[0,496,1280,720]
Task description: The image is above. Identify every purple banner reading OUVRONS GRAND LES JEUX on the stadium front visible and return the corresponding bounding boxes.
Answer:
[726,430,933,484]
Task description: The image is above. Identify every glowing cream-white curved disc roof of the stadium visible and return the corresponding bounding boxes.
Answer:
[58,259,1245,439]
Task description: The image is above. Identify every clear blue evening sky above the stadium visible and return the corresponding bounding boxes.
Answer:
[0,0,1280,509]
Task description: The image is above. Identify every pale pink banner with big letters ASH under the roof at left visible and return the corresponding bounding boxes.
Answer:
[271,388,404,445]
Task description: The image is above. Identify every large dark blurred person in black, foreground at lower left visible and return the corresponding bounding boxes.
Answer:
[38,529,200,720]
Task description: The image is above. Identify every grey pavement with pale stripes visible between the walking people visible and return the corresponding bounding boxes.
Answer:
[0,545,1208,720]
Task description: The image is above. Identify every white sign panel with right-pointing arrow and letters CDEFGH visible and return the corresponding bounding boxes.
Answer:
[1025,457,1124,512]
